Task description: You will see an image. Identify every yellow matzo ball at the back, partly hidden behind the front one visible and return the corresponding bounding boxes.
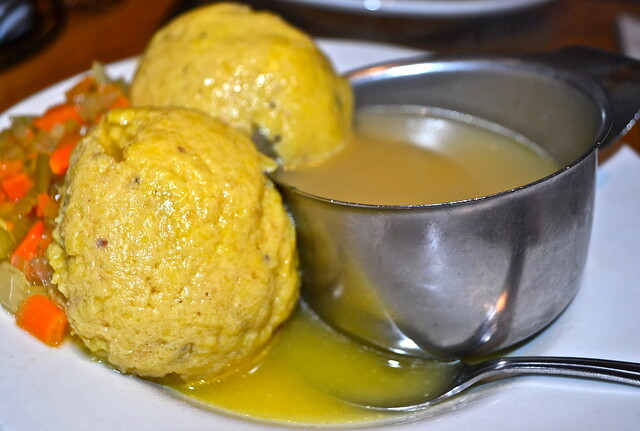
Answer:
[131,3,353,169]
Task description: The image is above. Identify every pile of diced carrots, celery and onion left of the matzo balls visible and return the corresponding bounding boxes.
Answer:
[0,64,129,346]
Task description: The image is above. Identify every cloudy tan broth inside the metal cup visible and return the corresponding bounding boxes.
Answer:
[277,107,560,205]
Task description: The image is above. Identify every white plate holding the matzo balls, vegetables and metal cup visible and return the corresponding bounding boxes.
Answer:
[0,41,640,431]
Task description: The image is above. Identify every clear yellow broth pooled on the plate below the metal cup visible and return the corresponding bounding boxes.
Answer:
[168,306,457,427]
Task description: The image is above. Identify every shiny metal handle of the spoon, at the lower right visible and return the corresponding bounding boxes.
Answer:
[468,356,640,386]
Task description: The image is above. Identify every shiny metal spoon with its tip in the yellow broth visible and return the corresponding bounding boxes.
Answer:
[365,356,640,412]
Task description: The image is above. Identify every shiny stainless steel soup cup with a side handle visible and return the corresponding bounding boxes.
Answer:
[275,48,640,357]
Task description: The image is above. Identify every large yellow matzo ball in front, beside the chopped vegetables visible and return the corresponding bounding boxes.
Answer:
[47,109,298,381]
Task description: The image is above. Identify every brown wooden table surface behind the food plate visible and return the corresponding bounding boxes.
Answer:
[0,0,640,151]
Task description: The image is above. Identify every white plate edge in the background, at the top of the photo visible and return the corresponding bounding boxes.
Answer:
[276,0,553,19]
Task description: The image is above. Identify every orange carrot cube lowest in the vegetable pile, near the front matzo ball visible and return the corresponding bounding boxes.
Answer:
[16,294,67,347]
